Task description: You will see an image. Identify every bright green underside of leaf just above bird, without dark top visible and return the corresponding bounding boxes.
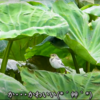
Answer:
[25,42,68,59]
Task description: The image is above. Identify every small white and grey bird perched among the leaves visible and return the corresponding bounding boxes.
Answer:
[49,54,74,73]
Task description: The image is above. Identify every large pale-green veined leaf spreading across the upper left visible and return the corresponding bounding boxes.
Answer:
[0,2,68,40]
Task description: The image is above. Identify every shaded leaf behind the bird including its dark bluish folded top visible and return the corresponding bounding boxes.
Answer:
[25,36,69,59]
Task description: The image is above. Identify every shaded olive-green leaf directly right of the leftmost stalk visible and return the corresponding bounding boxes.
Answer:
[9,34,46,61]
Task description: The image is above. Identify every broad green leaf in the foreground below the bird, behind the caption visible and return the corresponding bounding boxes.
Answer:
[21,68,100,100]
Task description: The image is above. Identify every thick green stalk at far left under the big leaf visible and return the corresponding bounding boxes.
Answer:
[1,40,13,73]
